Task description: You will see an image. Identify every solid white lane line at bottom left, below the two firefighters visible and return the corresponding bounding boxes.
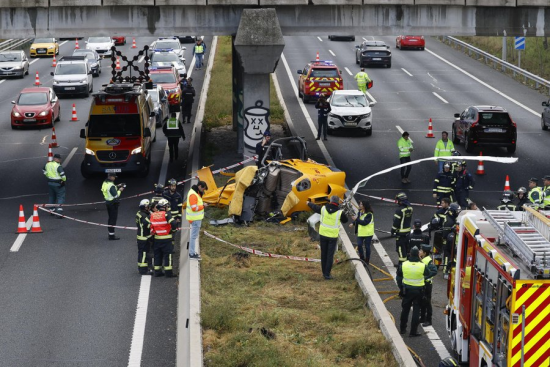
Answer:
[128,275,152,367]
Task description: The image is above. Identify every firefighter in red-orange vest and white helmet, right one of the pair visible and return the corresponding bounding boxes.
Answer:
[149,199,176,278]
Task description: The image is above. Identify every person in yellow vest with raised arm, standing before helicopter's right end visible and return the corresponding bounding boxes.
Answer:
[307,195,348,280]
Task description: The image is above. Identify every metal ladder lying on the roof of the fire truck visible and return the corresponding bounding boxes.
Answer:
[483,210,550,278]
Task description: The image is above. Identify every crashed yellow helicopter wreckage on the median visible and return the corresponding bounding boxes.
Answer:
[198,136,347,223]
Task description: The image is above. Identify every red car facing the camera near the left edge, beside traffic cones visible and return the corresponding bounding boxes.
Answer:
[11,87,61,129]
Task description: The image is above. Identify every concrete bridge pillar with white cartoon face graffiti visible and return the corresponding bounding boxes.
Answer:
[233,9,285,156]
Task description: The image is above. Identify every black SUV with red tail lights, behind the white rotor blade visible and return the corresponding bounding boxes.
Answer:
[452,106,517,153]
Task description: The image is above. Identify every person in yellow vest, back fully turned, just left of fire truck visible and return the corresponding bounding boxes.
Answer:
[396,247,430,336]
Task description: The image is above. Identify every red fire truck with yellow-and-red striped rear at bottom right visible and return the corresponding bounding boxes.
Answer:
[445,207,550,367]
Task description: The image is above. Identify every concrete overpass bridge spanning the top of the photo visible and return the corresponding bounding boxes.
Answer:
[0,0,550,38]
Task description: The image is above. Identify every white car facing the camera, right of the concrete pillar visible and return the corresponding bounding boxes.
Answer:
[328,90,374,136]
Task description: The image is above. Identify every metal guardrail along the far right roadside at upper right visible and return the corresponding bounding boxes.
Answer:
[437,36,550,94]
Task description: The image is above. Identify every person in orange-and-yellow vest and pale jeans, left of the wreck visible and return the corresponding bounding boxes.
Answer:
[185,181,208,260]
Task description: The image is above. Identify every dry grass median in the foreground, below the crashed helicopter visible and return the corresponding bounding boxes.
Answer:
[201,217,397,367]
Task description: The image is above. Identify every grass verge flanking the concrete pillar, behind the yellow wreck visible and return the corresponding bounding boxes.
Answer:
[204,36,284,131]
